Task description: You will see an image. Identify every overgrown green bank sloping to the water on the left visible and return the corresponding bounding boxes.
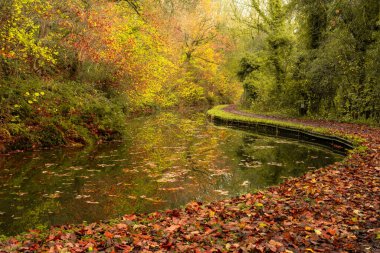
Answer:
[0,78,127,153]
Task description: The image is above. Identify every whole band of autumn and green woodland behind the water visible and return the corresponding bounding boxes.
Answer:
[0,0,380,152]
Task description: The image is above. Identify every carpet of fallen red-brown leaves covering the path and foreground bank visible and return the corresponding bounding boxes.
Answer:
[0,108,380,252]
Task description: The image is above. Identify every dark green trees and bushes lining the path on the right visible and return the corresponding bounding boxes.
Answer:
[238,0,380,122]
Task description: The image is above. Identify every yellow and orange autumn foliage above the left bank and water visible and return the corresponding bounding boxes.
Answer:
[0,0,238,111]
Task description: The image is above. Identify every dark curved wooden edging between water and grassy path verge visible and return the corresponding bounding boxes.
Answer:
[209,114,355,154]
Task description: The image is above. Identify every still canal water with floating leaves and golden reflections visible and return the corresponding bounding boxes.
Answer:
[0,113,342,235]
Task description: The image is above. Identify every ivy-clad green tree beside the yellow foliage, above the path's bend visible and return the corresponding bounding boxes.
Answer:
[235,0,292,107]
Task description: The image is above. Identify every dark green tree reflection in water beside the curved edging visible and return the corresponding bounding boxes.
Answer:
[236,134,342,188]
